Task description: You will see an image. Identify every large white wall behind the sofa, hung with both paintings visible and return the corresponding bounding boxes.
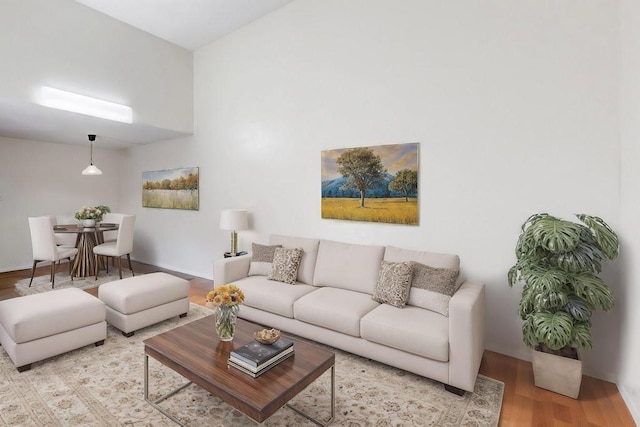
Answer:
[121,0,623,381]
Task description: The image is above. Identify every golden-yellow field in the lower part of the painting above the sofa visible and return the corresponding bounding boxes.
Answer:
[322,197,418,225]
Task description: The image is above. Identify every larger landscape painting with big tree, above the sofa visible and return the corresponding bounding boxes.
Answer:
[322,143,418,225]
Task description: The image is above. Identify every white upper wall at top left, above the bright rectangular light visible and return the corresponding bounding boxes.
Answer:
[0,0,193,133]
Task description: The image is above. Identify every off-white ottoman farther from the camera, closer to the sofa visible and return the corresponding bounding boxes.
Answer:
[98,273,189,337]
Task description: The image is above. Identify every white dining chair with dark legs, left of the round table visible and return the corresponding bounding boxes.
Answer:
[29,216,78,288]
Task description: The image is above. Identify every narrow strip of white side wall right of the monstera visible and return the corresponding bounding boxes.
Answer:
[617,0,640,420]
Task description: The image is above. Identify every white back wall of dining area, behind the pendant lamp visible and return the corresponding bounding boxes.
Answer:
[0,137,124,272]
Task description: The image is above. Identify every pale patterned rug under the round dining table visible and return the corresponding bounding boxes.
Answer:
[14,265,134,295]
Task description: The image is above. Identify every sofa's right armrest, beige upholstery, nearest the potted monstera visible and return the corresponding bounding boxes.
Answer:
[449,282,485,391]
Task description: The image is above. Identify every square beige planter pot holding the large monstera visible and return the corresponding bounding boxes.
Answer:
[531,350,582,399]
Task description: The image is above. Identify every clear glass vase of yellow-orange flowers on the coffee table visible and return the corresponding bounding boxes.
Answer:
[207,284,244,341]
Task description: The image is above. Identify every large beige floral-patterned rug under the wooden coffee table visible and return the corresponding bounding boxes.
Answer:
[0,304,504,427]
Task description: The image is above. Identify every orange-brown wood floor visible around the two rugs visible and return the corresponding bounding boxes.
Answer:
[0,262,636,427]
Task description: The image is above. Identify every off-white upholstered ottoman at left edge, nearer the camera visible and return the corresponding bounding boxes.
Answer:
[0,288,107,372]
